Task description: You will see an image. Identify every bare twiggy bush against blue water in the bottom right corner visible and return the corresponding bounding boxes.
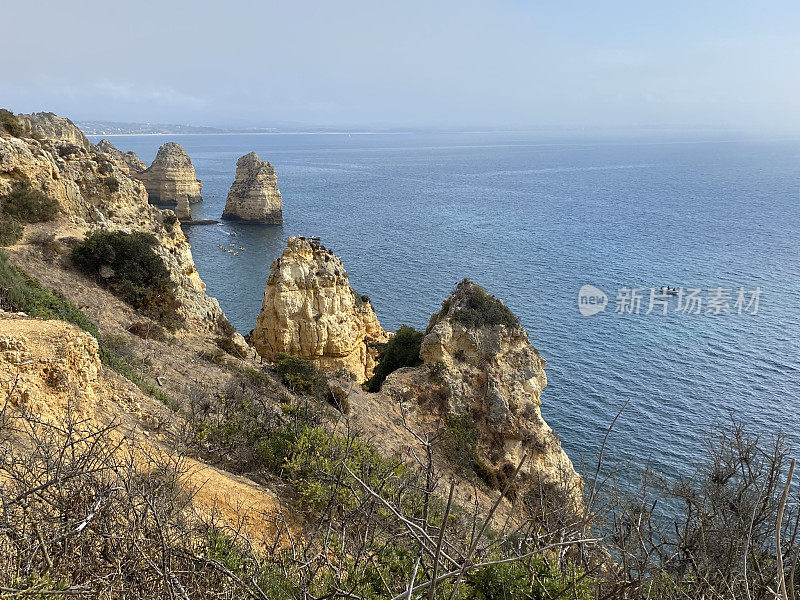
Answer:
[596,424,800,600]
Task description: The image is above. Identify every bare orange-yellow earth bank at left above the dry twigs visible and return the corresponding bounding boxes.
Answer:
[0,310,290,539]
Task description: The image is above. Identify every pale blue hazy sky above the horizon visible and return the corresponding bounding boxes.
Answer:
[0,0,800,132]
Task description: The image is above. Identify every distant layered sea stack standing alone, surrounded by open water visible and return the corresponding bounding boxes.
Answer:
[222,152,283,224]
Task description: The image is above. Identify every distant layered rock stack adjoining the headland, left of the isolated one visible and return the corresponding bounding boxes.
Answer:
[136,142,203,204]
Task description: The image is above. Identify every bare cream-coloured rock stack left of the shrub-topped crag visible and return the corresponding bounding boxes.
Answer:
[251,237,387,382]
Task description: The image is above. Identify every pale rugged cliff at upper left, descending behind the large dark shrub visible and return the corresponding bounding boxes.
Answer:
[0,127,222,325]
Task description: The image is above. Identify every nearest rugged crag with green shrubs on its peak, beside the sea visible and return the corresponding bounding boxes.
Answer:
[382,280,582,505]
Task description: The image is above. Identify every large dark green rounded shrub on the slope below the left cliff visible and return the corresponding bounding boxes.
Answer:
[72,231,182,330]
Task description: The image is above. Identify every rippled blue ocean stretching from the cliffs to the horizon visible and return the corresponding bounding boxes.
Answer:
[92,133,800,482]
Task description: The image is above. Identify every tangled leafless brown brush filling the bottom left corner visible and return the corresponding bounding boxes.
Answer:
[0,392,266,599]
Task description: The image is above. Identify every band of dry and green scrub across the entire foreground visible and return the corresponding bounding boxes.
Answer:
[0,346,800,600]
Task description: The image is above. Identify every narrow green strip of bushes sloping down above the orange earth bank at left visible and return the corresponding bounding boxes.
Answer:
[0,250,177,410]
